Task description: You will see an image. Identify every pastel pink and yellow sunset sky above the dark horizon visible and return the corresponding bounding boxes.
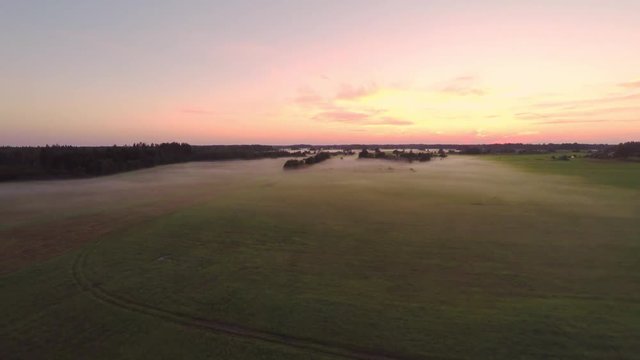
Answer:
[0,0,640,145]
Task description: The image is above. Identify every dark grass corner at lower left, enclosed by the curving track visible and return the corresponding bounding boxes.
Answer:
[0,254,330,359]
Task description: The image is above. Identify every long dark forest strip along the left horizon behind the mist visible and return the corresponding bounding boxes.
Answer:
[0,142,304,181]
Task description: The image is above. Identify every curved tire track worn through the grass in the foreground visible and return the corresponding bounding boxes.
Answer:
[72,243,440,360]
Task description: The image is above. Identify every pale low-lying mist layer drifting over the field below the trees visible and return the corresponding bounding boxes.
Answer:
[0,156,636,226]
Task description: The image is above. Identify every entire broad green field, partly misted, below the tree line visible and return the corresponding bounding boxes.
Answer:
[0,156,640,359]
